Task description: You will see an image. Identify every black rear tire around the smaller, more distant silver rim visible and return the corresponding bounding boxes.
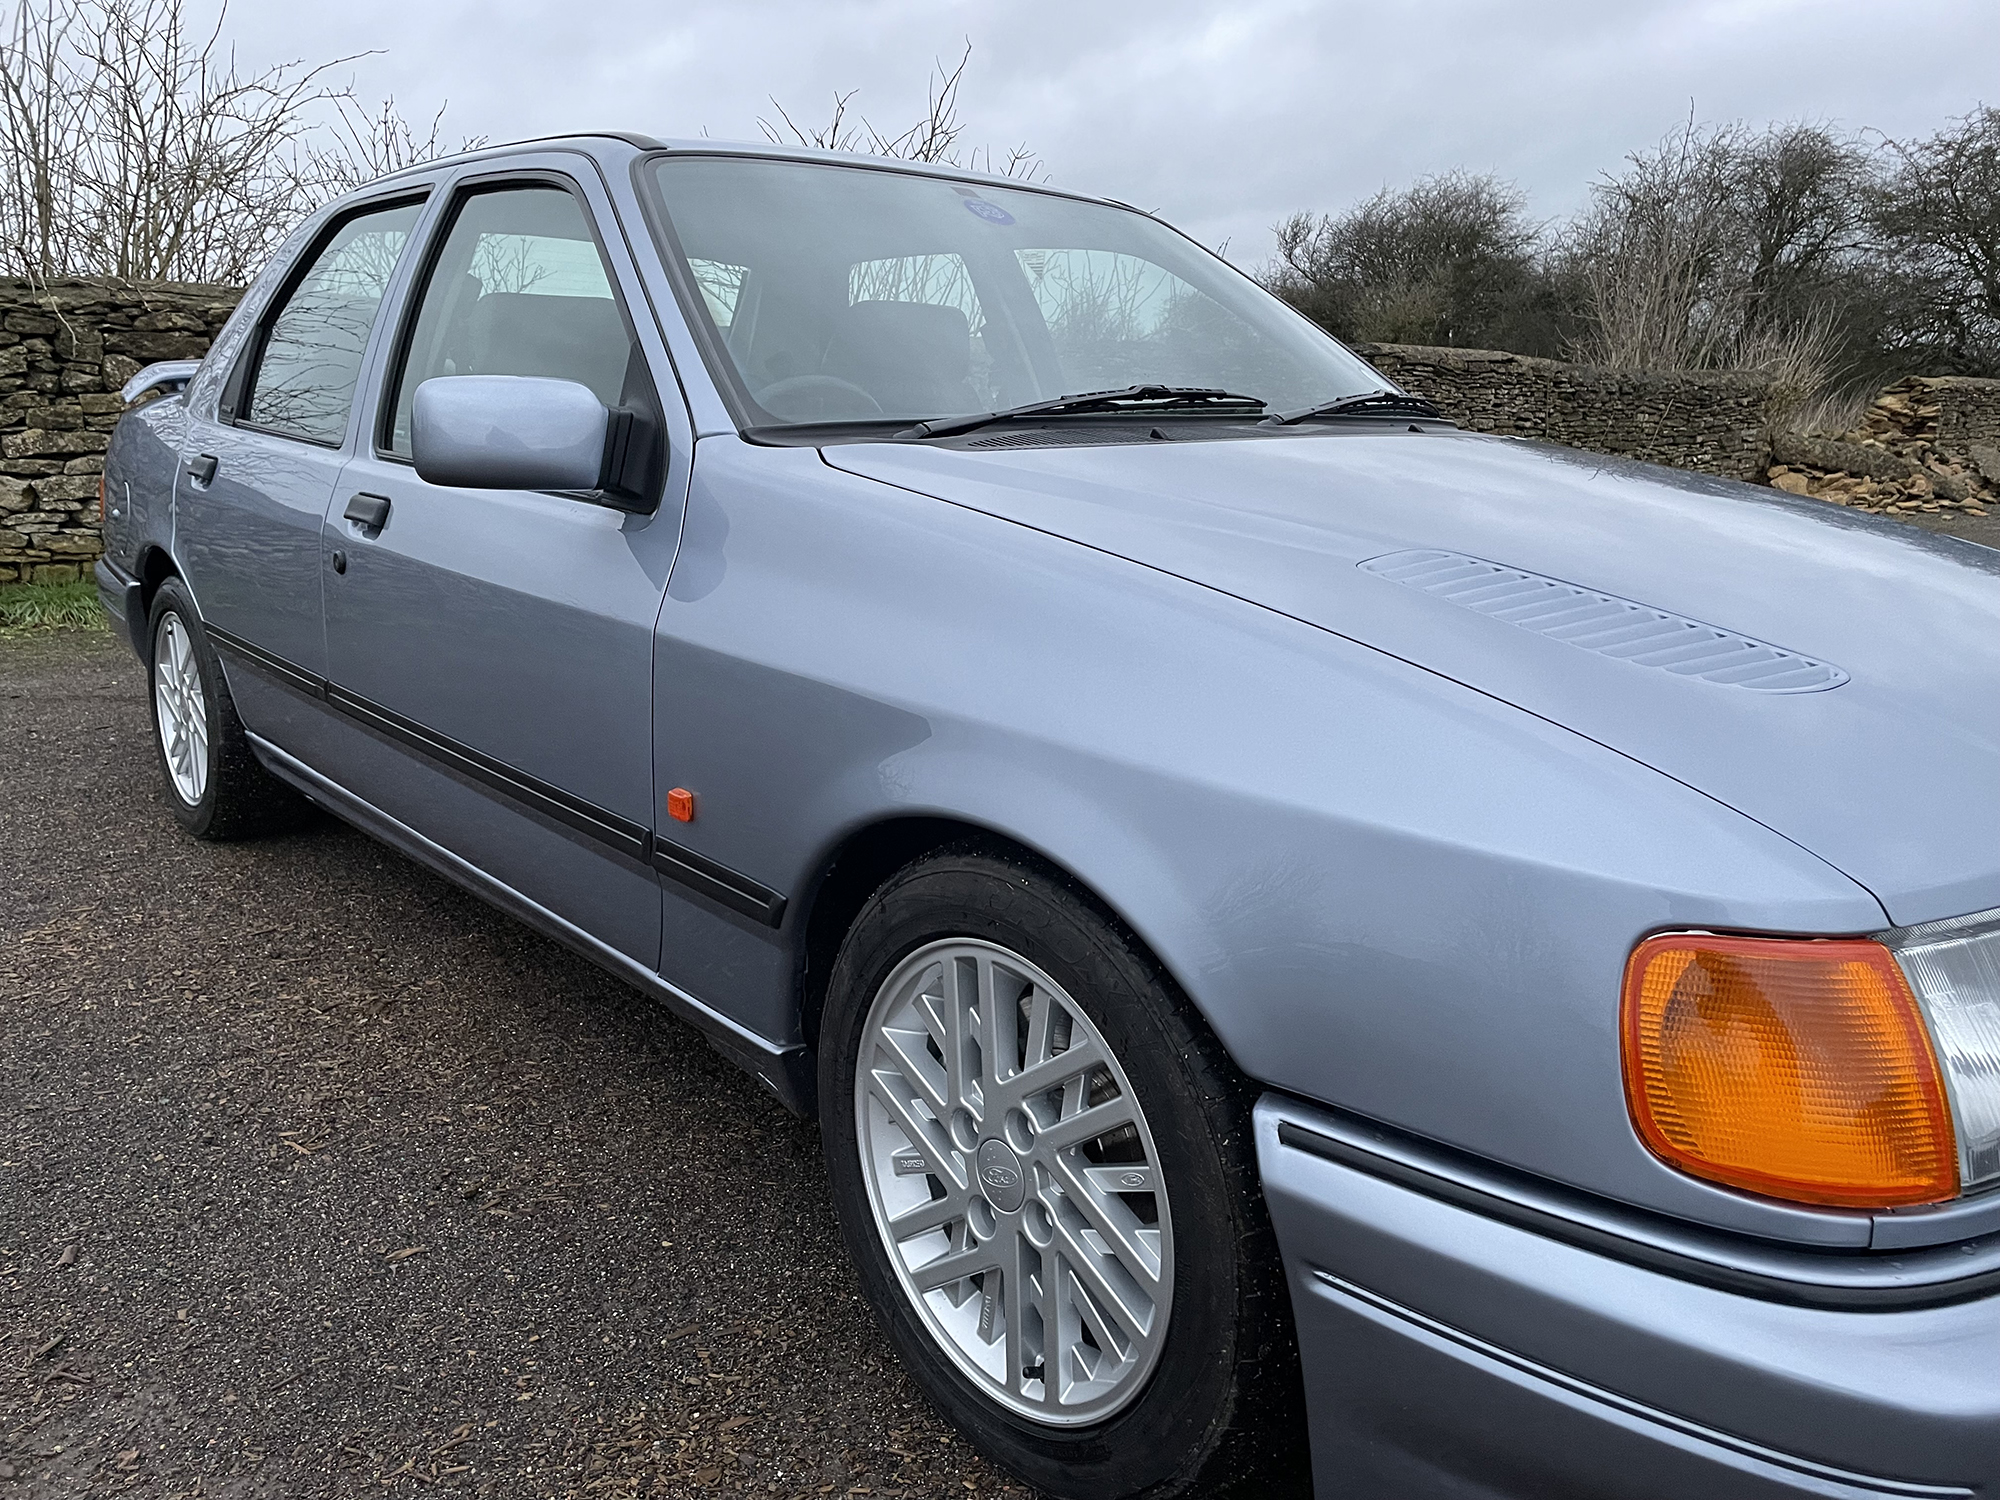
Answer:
[146,578,312,842]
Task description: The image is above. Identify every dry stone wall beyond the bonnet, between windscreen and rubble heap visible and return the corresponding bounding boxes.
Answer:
[1354,344,1770,480]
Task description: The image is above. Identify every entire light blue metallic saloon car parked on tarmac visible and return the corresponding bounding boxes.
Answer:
[98,136,2000,1500]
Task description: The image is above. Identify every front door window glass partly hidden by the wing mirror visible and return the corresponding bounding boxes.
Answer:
[384,184,652,458]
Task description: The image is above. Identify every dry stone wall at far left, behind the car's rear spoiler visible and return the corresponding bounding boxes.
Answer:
[0,280,240,584]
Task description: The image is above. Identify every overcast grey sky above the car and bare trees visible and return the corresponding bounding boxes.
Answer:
[228,0,2000,266]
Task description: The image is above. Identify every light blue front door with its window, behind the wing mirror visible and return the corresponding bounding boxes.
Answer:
[322,168,690,970]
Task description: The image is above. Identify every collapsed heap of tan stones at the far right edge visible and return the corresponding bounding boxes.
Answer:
[1768,376,2000,516]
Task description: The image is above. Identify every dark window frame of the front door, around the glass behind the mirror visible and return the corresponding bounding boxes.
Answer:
[368,164,678,512]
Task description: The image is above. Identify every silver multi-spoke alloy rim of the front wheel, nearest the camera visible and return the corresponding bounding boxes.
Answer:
[854,938,1174,1426]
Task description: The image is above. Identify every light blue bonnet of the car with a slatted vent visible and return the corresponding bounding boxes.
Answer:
[826,424,2000,924]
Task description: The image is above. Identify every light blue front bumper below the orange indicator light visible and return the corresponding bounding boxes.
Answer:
[1256,1096,2000,1500]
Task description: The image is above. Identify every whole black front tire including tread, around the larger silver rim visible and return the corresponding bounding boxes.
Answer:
[818,848,1310,1500]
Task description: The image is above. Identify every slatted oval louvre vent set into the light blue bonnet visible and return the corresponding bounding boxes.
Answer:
[1358,552,1848,692]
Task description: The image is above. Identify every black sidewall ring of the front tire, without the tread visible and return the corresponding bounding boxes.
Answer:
[820,856,1242,1496]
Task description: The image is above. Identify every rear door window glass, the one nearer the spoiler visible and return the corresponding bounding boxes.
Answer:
[242,202,422,446]
